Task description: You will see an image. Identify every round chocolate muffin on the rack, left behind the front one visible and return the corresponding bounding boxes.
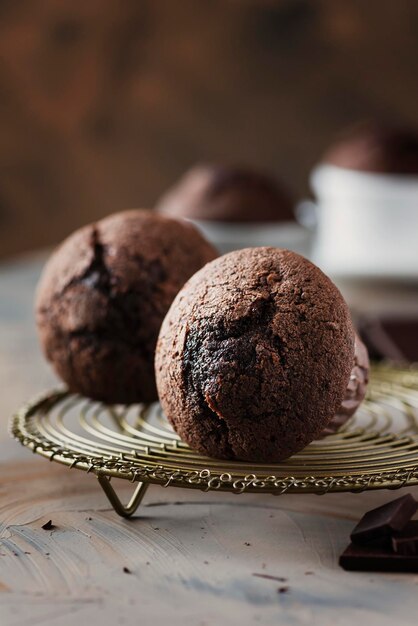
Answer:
[35,210,216,403]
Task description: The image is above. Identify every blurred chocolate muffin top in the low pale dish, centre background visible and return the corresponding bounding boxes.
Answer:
[157,165,295,222]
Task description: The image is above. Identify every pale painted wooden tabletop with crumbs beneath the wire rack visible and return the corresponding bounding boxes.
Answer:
[0,251,418,626]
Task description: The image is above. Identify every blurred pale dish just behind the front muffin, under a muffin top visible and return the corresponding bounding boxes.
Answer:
[190,220,312,256]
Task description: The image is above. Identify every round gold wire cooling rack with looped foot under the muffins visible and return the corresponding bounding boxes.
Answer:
[10,365,418,517]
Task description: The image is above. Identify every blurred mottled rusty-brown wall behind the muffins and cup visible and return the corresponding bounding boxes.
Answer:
[0,0,418,256]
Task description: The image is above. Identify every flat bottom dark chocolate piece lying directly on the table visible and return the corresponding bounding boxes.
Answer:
[339,543,418,572]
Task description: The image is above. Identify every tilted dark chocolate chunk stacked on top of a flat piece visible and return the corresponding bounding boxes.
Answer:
[350,493,418,545]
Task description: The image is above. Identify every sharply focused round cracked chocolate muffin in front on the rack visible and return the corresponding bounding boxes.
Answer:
[156,248,354,462]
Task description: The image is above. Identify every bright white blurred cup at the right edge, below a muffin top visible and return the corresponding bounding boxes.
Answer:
[311,165,418,280]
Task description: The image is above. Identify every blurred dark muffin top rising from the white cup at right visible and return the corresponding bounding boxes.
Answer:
[322,124,418,175]
